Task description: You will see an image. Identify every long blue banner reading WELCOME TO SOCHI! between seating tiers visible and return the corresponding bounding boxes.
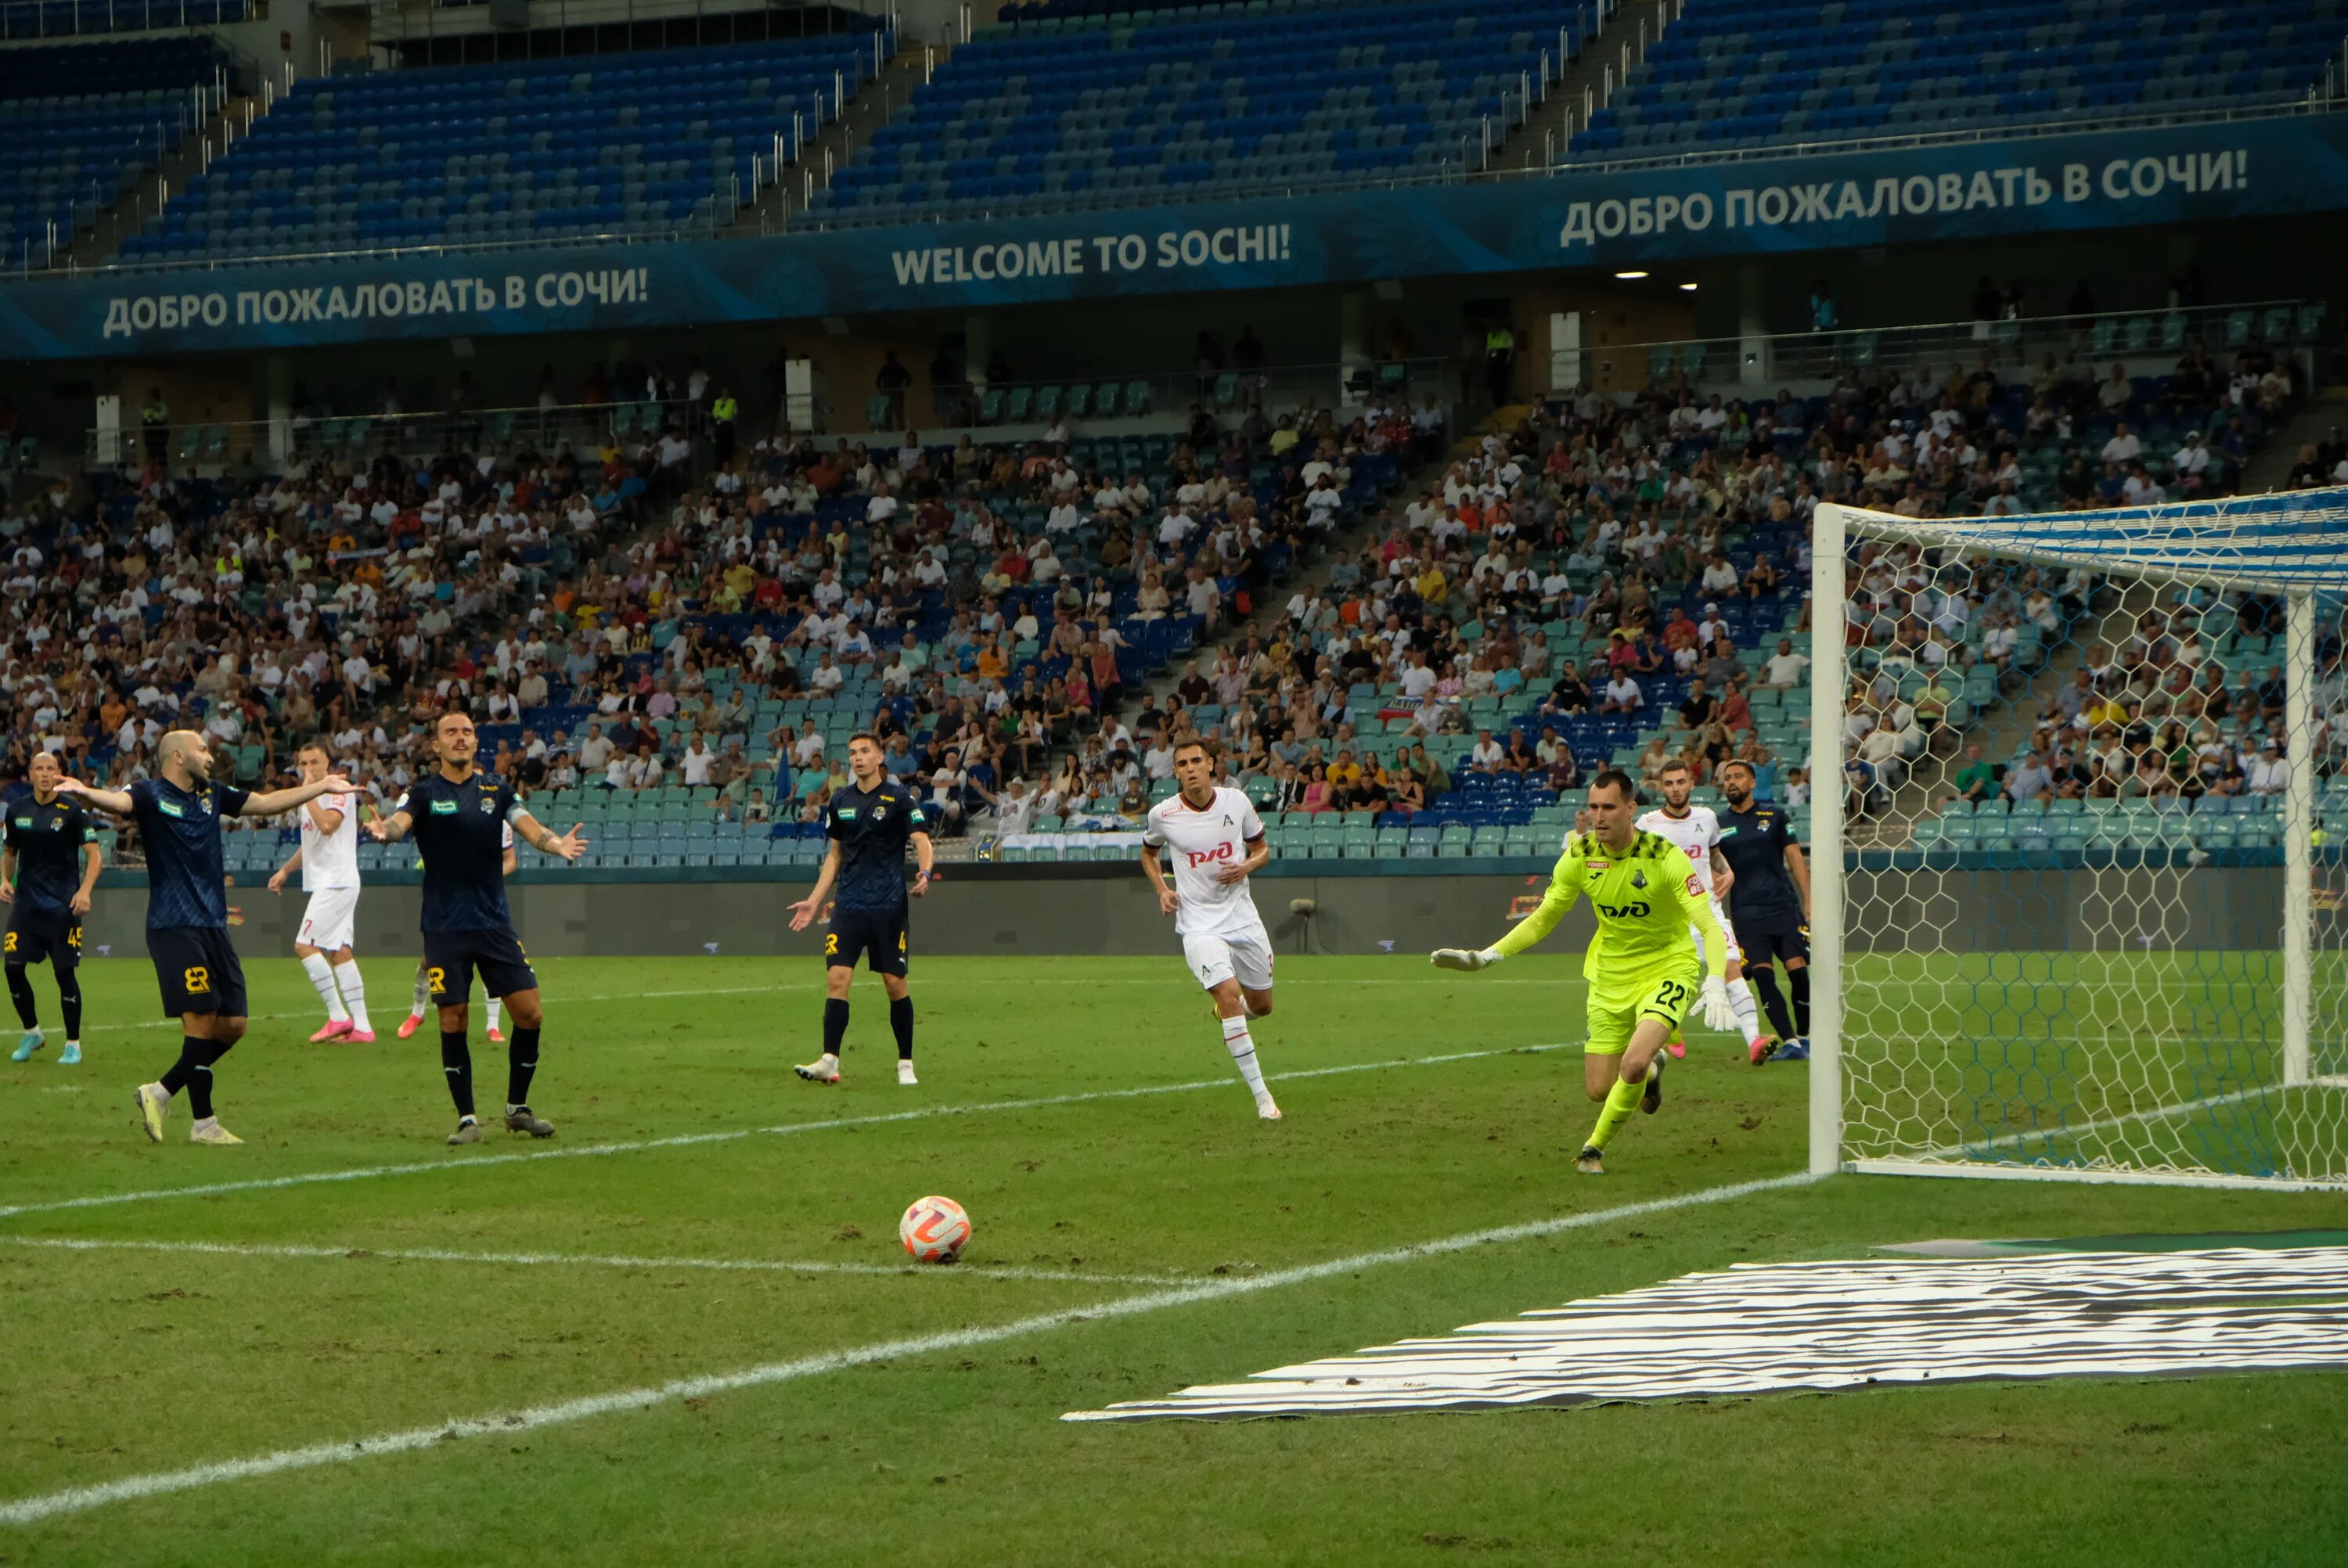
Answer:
[13,113,2348,359]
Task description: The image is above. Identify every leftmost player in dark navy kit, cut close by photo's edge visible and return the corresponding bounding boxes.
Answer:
[0,751,99,1068]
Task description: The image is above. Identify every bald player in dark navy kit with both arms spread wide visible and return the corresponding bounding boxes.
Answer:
[56,730,350,1143]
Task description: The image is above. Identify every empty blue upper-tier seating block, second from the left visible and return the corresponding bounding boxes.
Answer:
[122,33,895,258]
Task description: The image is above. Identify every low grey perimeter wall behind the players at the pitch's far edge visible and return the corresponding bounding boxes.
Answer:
[85,864,2282,960]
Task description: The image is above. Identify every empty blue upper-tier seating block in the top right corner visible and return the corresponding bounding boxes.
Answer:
[1573,0,2348,155]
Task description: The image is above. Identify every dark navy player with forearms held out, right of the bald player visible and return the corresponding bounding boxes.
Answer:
[366,711,587,1143]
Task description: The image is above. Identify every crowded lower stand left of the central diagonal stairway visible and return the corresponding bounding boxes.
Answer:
[0,376,1397,876]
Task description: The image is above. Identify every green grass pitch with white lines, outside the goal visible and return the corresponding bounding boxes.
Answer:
[0,953,2348,1568]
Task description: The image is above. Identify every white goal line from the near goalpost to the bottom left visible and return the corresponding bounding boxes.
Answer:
[0,1171,1817,1523]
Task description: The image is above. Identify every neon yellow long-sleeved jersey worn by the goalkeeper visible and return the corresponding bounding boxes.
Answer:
[1493,831,1728,981]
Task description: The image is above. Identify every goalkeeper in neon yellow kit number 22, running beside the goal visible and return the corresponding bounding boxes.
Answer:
[1432,768,1735,1176]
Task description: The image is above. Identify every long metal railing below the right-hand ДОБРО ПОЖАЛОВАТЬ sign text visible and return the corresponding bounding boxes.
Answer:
[1550,300,2329,394]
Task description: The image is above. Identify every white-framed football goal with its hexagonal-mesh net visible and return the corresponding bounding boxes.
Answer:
[1808,491,2348,1185]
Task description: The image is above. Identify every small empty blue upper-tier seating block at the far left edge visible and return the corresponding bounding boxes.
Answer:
[0,38,223,265]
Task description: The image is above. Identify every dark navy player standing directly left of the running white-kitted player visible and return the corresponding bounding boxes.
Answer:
[791,735,937,1084]
